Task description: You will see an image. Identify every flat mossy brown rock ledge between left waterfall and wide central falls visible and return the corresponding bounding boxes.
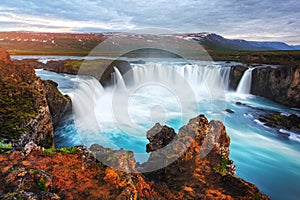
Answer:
[44,59,131,86]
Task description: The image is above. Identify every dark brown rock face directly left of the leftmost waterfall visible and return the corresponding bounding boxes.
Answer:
[43,80,72,127]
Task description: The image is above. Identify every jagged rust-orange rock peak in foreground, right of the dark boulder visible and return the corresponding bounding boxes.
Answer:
[138,115,268,199]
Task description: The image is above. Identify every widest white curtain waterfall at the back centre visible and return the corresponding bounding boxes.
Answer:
[128,63,231,92]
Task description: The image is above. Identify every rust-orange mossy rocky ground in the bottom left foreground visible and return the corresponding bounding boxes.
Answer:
[0,147,162,200]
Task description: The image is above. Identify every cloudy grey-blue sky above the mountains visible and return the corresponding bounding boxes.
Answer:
[0,0,300,45]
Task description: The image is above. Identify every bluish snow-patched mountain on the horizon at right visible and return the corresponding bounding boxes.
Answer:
[177,33,300,51]
